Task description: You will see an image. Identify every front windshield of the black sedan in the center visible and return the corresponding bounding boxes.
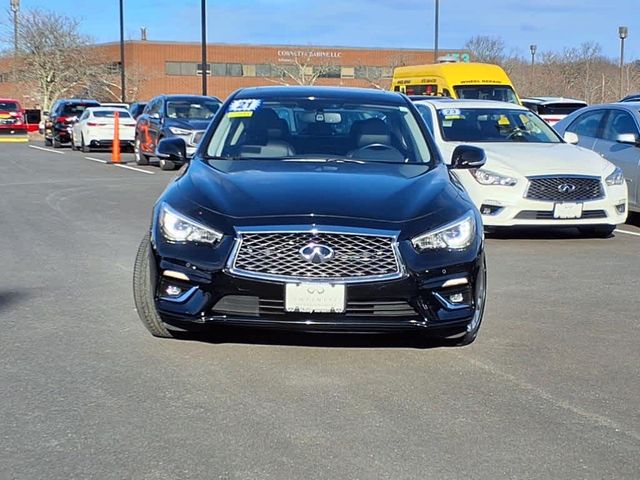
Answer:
[207,97,432,163]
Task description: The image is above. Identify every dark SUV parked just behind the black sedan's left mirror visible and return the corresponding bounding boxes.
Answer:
[135,95,222,170]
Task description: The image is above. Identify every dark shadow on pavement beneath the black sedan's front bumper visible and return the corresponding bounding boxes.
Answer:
[176,326,448,349]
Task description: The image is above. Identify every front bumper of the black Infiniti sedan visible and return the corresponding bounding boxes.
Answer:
[152,240,485,332]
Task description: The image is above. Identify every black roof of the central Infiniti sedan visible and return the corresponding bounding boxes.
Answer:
[233,86,407,105]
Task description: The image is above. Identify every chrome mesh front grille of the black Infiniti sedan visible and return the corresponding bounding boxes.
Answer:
[230,232,402,282]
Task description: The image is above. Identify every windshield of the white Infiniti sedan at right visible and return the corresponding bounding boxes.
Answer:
[438,108,562,143]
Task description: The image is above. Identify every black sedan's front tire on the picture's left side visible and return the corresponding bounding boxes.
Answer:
[133,233,173,338]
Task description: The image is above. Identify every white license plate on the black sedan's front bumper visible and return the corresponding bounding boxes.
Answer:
[284,283,345,313]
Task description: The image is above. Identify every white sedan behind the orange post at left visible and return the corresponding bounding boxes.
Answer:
[71,107,136,152]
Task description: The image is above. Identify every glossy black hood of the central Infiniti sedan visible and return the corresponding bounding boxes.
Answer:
[178,160,465,224]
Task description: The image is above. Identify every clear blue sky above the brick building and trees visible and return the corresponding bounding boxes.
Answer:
[13,0,640,59]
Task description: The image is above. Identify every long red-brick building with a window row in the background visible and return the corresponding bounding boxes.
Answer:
[0,40,464,106]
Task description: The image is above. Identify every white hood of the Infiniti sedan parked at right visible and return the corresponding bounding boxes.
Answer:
[442,142,614,177]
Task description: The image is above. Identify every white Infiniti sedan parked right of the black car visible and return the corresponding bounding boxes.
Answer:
[414,99,628,237]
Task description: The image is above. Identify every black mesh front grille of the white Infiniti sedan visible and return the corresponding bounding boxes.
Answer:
[525,176,604,202]
